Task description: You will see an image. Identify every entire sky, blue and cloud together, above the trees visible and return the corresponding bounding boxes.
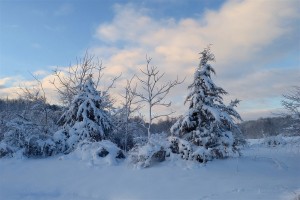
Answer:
[0,0,300,120]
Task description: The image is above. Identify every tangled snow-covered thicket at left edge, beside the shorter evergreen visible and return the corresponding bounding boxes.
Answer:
[0,94,61,157]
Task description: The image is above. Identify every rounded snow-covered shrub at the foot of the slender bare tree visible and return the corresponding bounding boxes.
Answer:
[128,134,170,168]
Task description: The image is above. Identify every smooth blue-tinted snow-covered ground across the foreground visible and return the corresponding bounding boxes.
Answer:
[0,138,300,200]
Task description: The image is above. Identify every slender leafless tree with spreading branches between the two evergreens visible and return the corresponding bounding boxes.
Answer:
[135,57,184,140]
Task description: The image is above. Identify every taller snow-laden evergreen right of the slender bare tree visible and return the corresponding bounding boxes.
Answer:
[170,46,241,162]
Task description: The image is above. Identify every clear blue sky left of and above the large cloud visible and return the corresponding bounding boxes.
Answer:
[0,0,222,78]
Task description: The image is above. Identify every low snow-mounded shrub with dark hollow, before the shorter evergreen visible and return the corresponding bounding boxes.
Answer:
[74,140,125,165]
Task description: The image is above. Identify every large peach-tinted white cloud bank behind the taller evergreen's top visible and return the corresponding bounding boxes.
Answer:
[95,0,300,119]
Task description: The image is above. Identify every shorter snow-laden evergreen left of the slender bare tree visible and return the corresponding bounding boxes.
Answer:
[54,75,113,153]
